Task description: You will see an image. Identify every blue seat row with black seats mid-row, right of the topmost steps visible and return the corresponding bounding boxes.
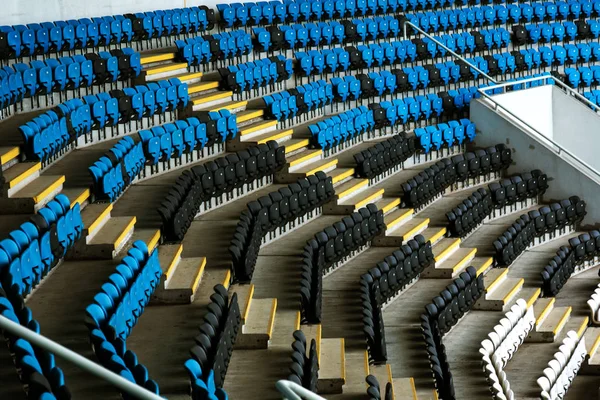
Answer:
[175,31,253,66]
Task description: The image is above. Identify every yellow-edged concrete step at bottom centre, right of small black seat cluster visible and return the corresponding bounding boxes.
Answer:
[318,338,346,394]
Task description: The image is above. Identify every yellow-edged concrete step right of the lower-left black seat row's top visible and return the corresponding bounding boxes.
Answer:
[236,298,277,349]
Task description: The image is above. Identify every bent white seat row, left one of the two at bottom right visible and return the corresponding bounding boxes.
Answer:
[479,299,535,400]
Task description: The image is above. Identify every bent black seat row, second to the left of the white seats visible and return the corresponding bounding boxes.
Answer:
[360,235,434,363]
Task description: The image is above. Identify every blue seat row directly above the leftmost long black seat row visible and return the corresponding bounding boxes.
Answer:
[138,109,238,165]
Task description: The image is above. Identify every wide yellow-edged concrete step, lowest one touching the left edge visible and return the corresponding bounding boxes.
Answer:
[0,174,65,214]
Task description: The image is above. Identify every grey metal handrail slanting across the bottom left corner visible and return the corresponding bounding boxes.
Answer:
[0,315,163,400]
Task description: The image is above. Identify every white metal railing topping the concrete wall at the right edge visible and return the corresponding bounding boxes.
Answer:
[477,75,600,182]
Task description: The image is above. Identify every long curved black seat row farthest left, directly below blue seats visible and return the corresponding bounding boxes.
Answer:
[158,141,285,241]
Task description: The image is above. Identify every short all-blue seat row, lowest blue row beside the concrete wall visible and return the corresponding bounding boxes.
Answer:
[414,118,476,153]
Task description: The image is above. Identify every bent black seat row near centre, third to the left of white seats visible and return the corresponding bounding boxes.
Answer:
[300,204,385,324]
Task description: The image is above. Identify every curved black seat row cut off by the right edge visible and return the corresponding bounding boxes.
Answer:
[541,230,600,296]
